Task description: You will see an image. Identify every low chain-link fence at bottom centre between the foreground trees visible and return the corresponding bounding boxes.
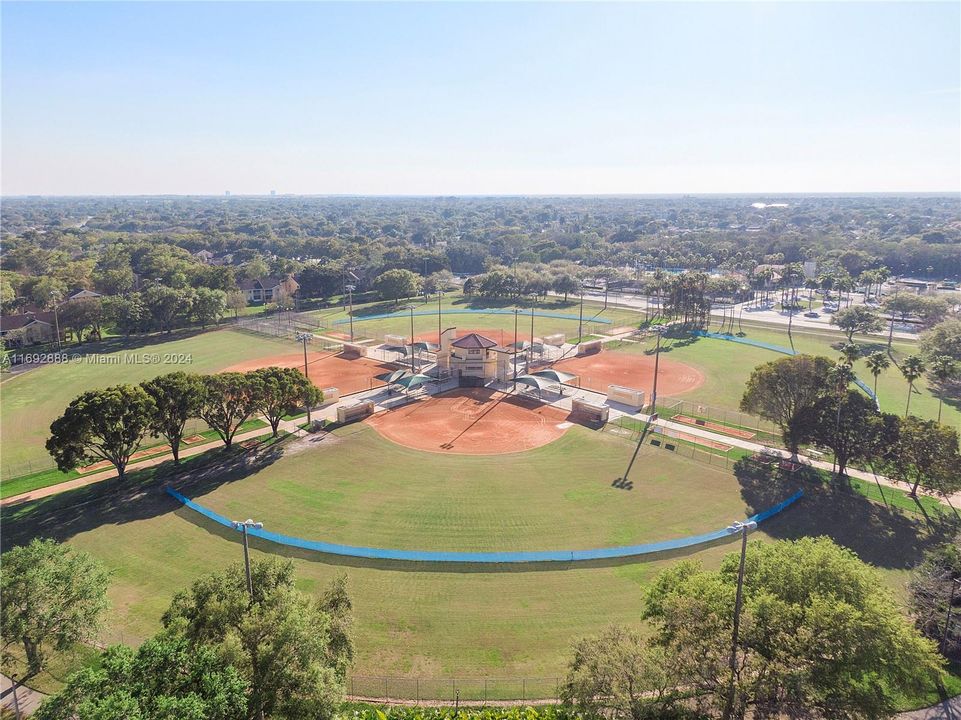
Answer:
[347,675,561,704]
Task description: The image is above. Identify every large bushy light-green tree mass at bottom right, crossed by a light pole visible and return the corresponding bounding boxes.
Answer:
[644,538,940,718]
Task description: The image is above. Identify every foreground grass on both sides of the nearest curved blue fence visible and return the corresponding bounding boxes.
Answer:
[2,425,944,678]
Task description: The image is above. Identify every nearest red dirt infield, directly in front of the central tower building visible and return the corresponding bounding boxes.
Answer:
[364,388,570,455]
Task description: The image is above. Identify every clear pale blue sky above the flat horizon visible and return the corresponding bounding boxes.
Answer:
[0,2,961,195]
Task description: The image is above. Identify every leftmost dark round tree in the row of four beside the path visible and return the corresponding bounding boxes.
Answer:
[47,385,157,481]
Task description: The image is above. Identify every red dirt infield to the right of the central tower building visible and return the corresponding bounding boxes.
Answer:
[554,350,704,400]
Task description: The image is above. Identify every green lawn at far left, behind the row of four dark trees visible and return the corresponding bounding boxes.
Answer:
[0,330,297,478]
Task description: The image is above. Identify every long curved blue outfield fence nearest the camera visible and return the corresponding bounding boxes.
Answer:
[167,488,804,563]
